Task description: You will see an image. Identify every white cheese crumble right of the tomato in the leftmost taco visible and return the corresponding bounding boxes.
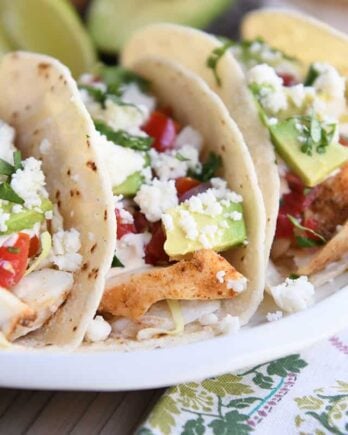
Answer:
[51,228,82,272]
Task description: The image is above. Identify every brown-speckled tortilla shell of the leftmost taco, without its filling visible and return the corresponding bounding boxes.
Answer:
[0,52,115,347]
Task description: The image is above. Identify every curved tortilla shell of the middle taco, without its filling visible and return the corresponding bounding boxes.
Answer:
[119,57,266,323]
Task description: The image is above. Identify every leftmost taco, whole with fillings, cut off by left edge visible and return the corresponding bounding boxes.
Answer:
[0,52,115,348]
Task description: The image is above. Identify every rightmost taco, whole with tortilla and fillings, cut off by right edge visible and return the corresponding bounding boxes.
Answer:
[124,10,348,311]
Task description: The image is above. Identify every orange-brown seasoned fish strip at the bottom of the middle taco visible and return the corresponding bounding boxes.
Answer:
[99,249,244,320]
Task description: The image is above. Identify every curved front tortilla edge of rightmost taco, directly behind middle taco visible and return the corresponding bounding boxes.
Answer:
[122,24,280,258]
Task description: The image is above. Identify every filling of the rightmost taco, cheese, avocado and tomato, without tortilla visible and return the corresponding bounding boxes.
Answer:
[227,39,348,311]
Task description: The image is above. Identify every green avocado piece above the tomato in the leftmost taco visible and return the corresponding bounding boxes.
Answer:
[0,198,53,235]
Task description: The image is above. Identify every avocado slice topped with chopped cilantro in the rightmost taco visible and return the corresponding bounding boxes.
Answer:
[270,119,348,187]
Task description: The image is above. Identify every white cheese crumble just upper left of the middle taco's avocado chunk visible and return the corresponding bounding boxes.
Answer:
[134,178,178,222]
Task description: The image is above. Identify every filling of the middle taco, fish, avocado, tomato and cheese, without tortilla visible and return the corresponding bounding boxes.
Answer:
[80,68,247,341]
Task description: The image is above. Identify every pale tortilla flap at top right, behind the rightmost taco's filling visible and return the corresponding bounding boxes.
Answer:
[241,9,348,76]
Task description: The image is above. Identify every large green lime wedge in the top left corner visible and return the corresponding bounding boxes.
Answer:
[0,0,96,76]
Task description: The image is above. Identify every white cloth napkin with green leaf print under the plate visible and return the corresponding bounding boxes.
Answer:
[137,332,348,435]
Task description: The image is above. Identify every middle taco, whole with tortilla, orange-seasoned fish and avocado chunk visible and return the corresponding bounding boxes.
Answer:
[79,57,266,345]
